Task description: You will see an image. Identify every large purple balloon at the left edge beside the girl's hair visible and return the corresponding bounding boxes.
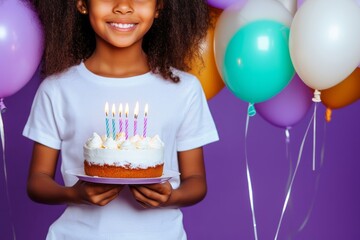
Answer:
[0,0,43,98]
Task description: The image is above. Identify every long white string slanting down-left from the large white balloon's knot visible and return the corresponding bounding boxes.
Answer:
[274,109,315,240]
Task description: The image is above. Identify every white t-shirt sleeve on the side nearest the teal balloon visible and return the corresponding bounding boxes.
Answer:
[177,79,219,151]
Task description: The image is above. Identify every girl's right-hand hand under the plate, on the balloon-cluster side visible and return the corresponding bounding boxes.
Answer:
[130,181,173,208]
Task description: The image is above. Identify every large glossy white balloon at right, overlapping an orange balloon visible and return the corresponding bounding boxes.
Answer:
[289,0,360,90]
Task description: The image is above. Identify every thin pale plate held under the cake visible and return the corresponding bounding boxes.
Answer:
[66,168,180,184]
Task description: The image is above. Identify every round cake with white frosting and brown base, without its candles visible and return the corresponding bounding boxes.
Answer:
[84,133,164,178]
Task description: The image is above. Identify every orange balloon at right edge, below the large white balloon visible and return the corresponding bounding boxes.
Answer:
[321,68,360,122]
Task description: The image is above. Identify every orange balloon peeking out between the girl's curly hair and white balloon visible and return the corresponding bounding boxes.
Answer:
[189,8,225,100]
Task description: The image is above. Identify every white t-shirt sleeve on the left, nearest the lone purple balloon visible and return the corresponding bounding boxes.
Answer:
[23,80,61,149]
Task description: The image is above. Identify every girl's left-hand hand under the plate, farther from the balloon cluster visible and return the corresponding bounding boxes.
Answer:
[72,181,124,206]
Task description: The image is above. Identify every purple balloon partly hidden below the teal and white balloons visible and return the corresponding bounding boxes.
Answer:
[255,74,313,128]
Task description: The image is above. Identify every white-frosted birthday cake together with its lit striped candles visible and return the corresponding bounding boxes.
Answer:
[83,102,164,178]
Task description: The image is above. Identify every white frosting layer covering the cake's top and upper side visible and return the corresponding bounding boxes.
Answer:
[84,133,164,168]
